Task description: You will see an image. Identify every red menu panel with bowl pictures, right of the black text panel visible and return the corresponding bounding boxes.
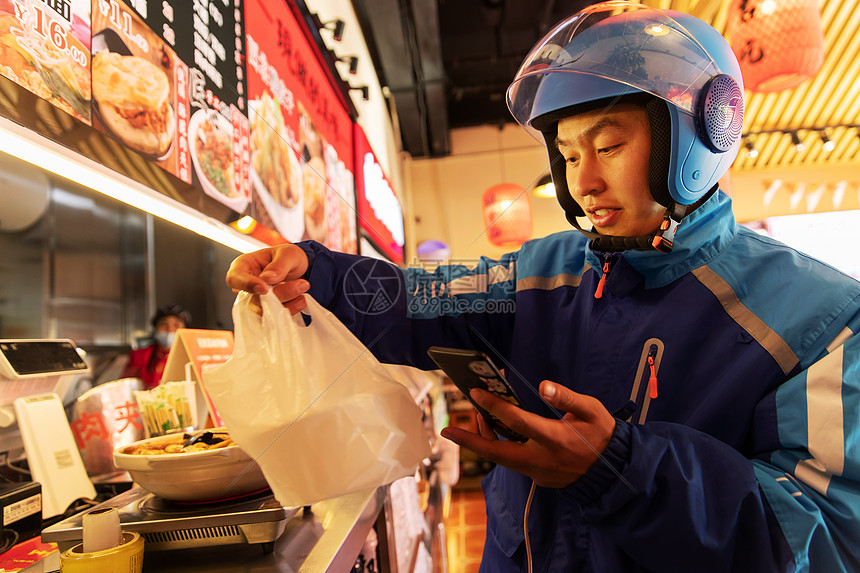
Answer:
[245,0,358,253]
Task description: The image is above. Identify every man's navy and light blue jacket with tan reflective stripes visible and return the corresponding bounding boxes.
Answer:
[302,193,860,573]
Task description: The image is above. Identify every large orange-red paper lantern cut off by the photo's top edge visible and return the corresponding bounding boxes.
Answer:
[726,0,824,92]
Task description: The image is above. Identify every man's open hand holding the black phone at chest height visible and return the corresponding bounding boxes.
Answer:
[442,380,615,488]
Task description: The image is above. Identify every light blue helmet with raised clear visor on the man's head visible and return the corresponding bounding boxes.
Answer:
[507,2,744,247]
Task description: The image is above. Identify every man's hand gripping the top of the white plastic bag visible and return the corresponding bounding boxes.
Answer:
[227,244,310,314]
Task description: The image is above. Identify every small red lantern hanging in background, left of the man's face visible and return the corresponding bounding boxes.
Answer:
[482,183,532,247]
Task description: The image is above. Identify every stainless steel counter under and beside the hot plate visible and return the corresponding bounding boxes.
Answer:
[24,487,388,573]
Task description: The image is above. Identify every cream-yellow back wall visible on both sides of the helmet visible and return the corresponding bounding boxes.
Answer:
[405,123,860,259]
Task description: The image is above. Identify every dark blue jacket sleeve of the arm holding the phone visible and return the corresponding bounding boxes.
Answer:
[564,308,860,573]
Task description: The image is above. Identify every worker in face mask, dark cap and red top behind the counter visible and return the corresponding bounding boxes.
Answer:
[122,304,191,390]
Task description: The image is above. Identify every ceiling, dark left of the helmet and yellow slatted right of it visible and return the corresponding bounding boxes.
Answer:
[353,0,860,170]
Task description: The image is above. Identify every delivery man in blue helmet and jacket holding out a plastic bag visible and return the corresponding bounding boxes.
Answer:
[227,2,860,573]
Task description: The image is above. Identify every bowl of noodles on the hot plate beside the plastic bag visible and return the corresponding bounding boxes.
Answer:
[113,428,269,501]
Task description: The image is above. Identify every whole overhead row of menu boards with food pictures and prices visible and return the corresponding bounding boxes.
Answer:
[0,0,358,252]
